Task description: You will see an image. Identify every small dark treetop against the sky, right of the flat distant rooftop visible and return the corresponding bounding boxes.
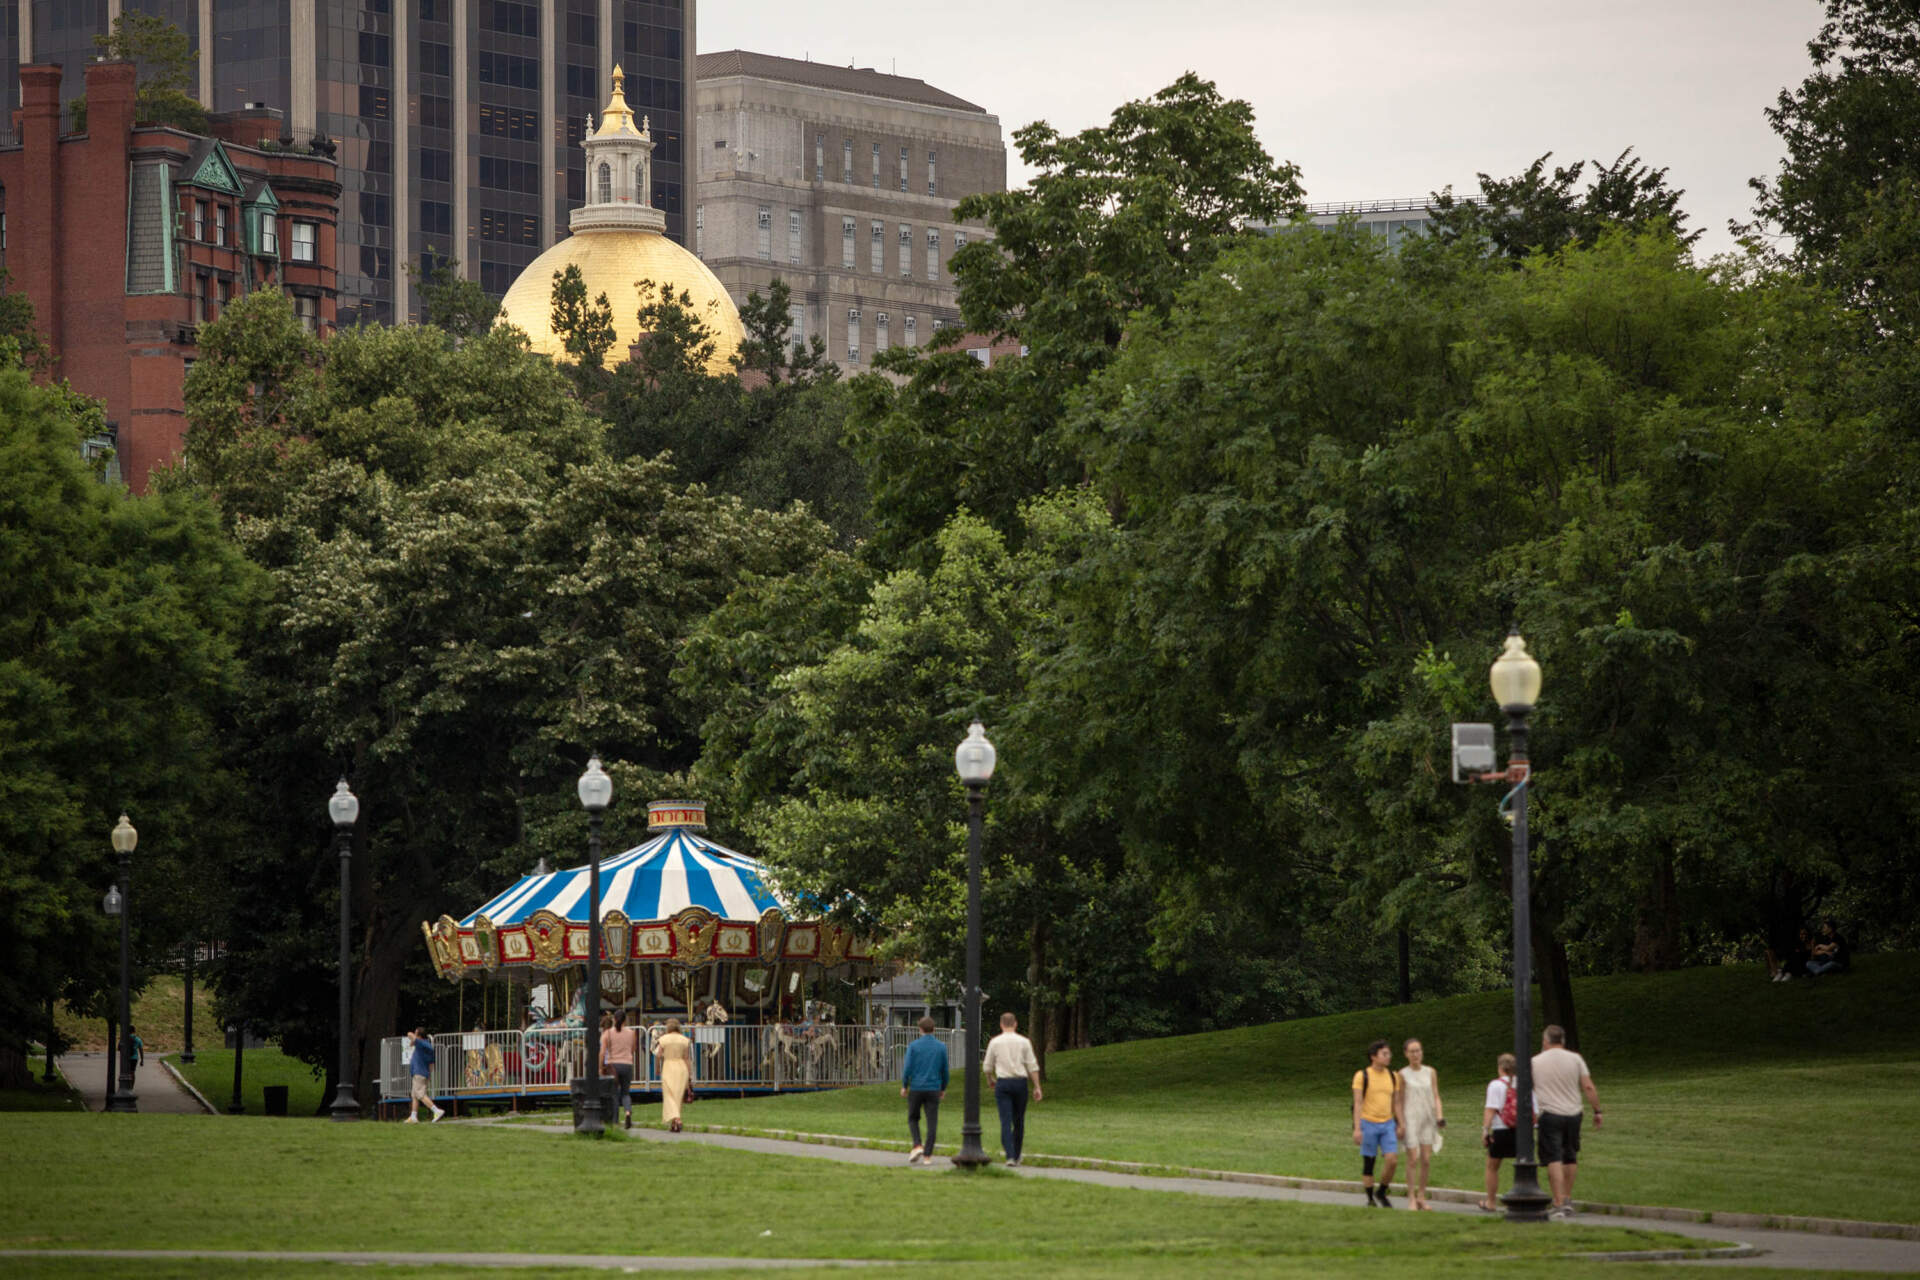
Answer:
[1428,148,1701,261]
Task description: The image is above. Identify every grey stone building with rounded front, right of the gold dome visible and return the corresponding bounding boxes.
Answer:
[693,50,1006,372]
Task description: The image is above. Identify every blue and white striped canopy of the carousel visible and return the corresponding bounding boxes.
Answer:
[461,827,789,929]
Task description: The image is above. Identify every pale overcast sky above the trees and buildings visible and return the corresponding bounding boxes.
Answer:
[699,0,1822,253]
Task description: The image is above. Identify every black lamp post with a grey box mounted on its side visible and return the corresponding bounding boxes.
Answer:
[1488,631,1553,1222]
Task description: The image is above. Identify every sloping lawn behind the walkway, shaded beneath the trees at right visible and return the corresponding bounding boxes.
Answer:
[687,954,1920,1222]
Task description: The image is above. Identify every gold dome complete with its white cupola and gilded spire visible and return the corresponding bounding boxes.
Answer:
[499,67,747,374]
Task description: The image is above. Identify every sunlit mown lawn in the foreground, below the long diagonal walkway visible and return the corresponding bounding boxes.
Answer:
[0,1115,1697,1276]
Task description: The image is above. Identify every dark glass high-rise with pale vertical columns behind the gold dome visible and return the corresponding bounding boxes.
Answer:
[0,0,695,324]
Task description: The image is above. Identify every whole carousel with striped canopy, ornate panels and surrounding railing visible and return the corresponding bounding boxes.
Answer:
[380,802,936,1107]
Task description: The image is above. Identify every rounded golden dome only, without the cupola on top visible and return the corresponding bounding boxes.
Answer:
[497,228,747,376]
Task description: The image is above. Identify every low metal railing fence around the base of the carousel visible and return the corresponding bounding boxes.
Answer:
[380,1023,960,1098]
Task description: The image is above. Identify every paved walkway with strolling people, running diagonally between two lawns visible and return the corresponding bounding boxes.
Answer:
[606,1125,1920,1274]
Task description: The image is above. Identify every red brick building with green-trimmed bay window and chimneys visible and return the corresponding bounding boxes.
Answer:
[0,61,340,493]
